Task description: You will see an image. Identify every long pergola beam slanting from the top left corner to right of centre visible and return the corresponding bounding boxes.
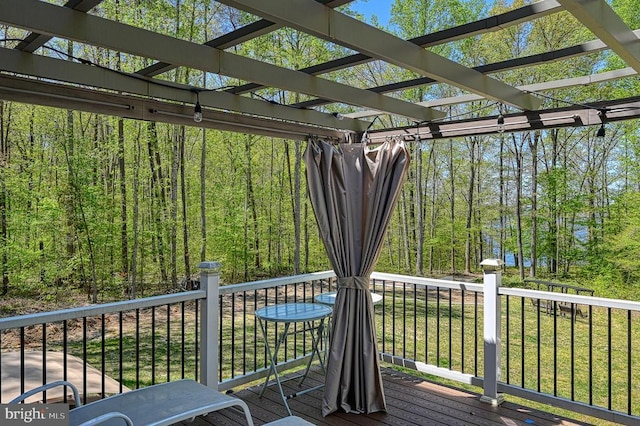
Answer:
[0,0,444,121]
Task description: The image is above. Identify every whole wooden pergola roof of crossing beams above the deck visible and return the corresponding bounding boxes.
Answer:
[0,0,640,140]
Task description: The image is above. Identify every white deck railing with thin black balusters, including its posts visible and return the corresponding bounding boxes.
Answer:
[0,262,640,424]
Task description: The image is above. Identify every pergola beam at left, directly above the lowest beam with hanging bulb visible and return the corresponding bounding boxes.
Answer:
[0,48,369,131]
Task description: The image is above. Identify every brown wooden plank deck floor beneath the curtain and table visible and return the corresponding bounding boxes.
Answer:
[183,368,587,426]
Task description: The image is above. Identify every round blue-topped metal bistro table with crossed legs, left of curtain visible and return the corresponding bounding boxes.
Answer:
[255,303,333,415]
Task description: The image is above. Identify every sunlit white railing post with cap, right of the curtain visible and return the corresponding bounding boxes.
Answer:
[480,259,504,406]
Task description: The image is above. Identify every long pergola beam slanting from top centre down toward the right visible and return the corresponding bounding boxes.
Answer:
[218,0,541,110]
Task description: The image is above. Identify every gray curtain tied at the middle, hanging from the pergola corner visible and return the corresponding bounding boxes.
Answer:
[304,140,409,416]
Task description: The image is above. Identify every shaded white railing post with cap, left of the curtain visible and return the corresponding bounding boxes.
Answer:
[198,262,222,390]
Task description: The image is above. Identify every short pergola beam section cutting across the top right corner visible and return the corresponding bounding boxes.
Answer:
[558,0,640,72]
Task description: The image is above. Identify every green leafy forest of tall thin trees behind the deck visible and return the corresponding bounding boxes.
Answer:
[0,0,640,302]
